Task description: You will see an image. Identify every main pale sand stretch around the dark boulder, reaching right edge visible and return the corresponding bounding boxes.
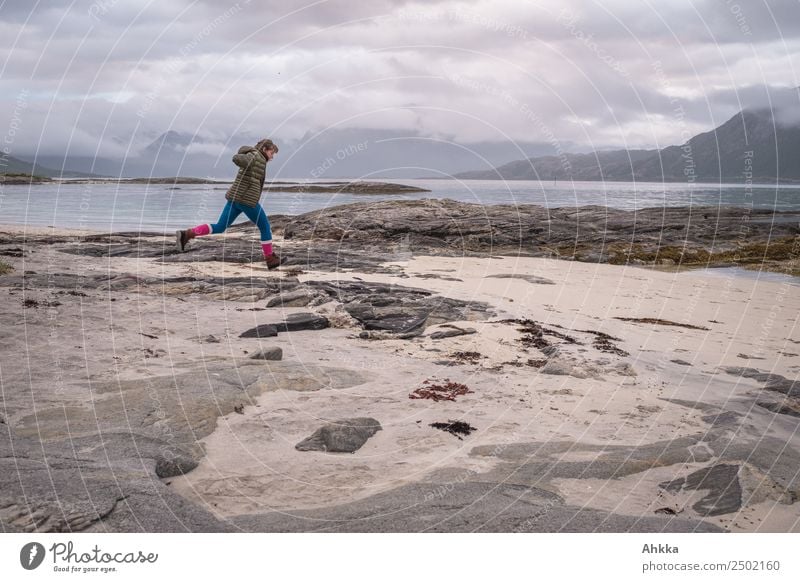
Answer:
[172,257,800,531]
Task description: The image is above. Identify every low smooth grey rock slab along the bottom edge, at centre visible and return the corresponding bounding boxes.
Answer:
[232,480,723,533]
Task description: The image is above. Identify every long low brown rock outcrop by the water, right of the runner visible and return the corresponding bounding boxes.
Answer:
[285,200,800,274]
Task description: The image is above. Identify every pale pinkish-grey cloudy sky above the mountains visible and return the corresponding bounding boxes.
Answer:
[0,0,800,156]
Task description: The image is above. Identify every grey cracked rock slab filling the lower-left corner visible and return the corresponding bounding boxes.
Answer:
[0,430,233,533]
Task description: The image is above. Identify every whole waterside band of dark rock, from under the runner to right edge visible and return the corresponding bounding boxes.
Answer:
[42,199,800,274]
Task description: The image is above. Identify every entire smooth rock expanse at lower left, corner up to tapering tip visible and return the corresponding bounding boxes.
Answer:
[0,360,366,532]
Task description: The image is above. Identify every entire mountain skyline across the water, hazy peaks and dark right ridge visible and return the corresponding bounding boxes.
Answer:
[7,101,800,182]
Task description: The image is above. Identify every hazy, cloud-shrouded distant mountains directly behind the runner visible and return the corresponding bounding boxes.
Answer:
[12,128,575,180]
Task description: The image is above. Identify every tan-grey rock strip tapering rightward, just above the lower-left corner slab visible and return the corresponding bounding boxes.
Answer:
[7,359,366,454]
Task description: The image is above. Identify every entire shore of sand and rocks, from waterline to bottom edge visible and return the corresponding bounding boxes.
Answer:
[0,200,800,532]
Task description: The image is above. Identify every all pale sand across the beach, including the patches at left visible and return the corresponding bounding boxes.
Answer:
[0,227,800,532]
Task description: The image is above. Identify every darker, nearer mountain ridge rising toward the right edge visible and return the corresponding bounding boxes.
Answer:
[456,109,800,183]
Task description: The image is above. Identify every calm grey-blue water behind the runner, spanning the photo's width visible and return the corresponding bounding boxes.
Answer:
[0,180,800,232]
